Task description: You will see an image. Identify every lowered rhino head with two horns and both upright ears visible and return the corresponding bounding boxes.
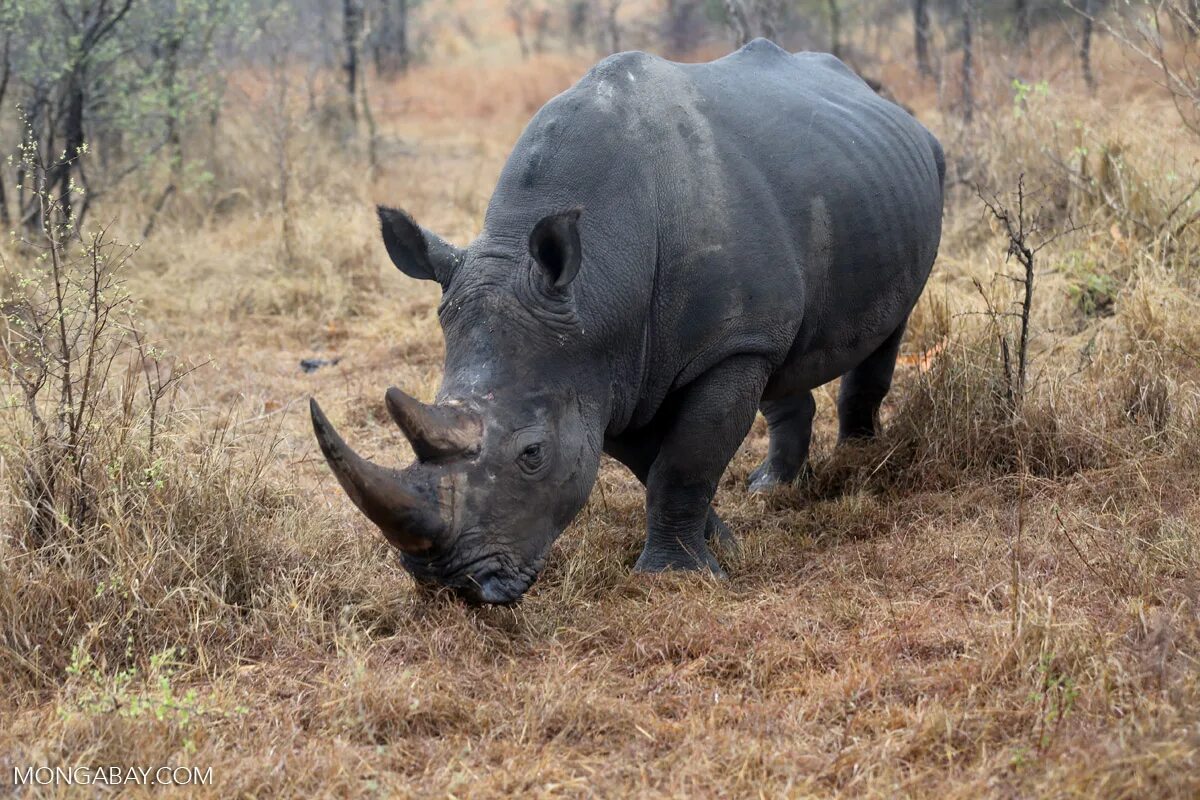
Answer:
[311,207,607,603]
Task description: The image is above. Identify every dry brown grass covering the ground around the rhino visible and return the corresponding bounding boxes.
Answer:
[0,14,1200,798]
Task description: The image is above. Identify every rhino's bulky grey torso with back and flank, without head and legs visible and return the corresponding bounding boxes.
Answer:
[485,40,942,425]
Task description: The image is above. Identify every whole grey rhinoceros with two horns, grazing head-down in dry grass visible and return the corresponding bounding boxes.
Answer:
[311,40,944,603]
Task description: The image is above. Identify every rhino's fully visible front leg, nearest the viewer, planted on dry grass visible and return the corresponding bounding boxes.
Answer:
[634,356,769,575]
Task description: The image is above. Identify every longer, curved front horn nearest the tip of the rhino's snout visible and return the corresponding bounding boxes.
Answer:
[308,398,445,553]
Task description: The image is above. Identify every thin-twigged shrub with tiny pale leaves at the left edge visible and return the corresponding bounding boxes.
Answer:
[0,145,182,546]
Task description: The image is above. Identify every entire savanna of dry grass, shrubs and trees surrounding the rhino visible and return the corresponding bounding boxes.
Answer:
[0,0,1200,798]
